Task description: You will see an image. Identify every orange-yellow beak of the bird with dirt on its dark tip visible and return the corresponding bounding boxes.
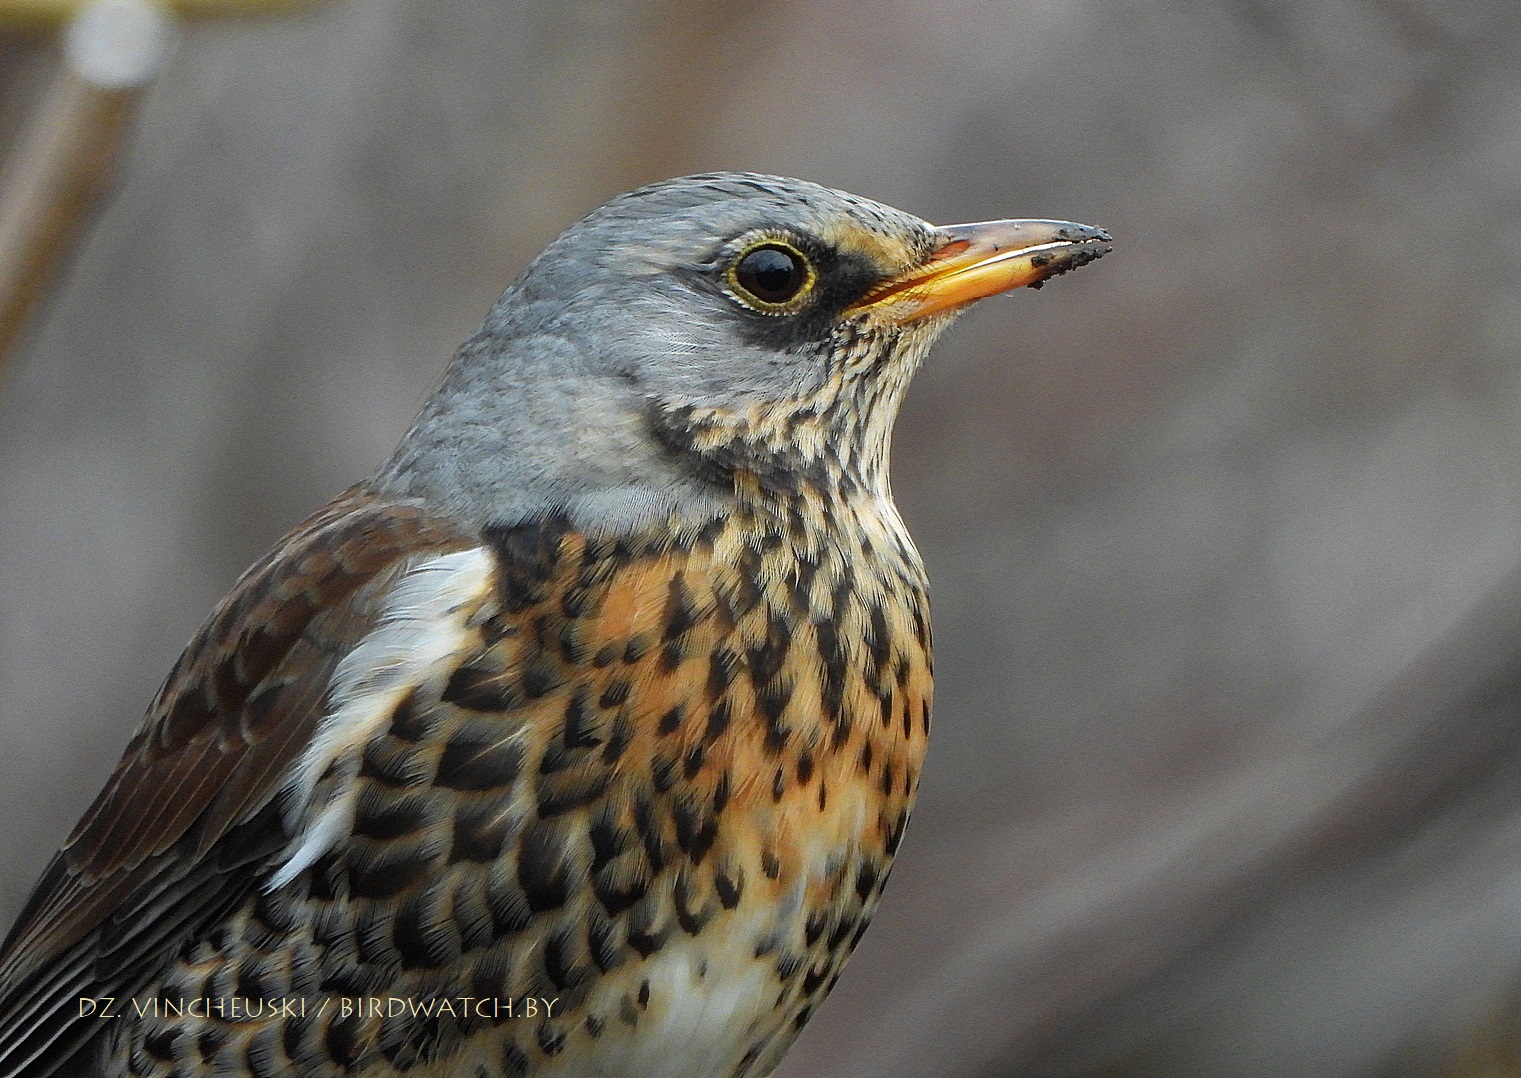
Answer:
[846,220,1113,322]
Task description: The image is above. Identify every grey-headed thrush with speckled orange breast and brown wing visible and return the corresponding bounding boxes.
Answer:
[0,173,1112,1078]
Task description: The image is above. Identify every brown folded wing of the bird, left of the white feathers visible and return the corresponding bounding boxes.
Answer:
[0,487,478,1073]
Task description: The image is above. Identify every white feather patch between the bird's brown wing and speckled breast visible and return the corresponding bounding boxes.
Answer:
[265,547,493,891]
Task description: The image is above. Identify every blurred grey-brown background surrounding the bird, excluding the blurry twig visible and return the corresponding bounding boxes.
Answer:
[0,0,1521,1078]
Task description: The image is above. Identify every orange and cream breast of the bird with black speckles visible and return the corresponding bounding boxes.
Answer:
[113,503,931,1078]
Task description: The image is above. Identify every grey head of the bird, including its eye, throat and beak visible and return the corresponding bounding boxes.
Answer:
[376,173,1109,531]
